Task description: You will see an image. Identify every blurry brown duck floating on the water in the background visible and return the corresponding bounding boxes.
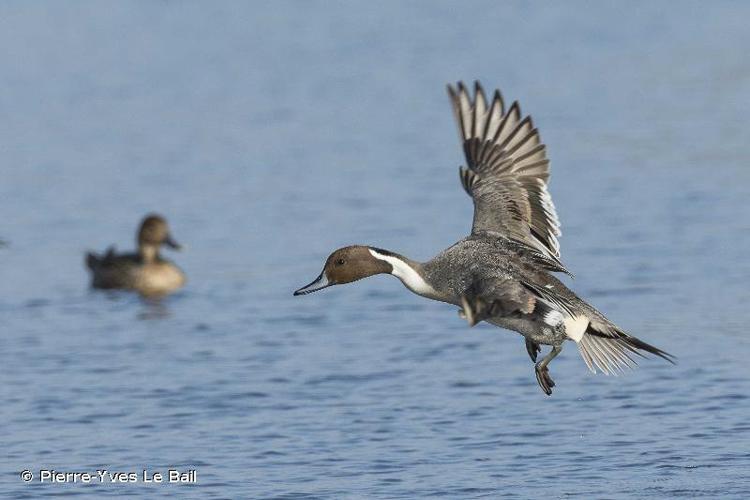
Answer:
[86,214,185,296]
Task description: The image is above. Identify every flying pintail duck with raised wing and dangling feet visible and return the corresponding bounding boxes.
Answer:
[294,82,674,395]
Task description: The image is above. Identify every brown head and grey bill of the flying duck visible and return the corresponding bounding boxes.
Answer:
[294,245,393,295]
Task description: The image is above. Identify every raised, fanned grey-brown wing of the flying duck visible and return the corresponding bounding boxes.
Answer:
[448,82,560,259]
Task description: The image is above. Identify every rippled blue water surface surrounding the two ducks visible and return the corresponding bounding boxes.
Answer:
[0,2,750,499]
